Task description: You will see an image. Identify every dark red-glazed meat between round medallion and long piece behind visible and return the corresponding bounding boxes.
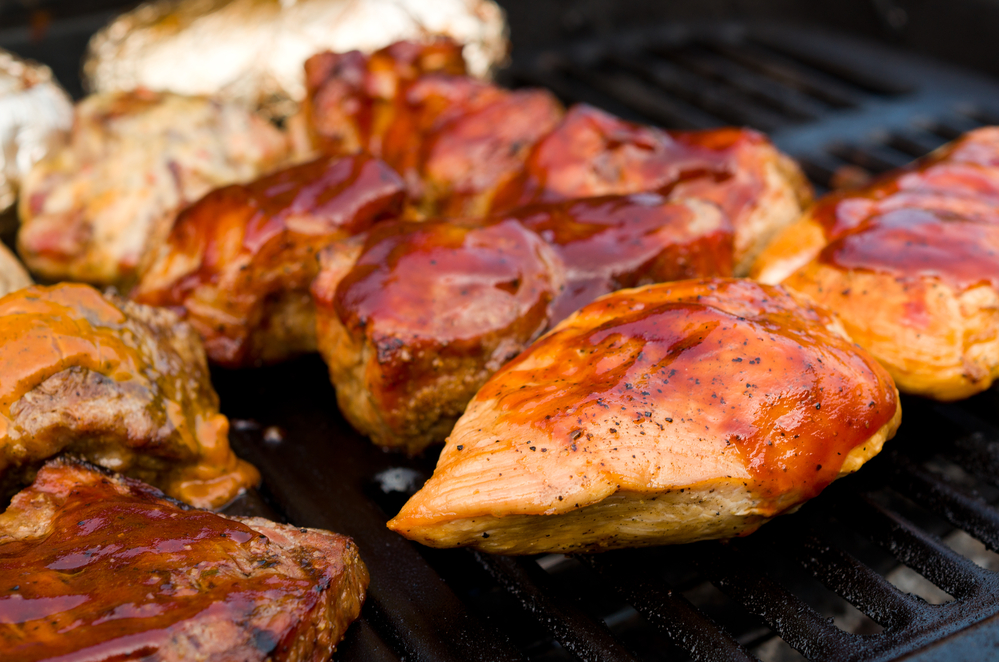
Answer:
[508,193,733,325]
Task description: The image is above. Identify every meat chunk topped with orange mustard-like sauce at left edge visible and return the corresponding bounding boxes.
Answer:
[0,284,259,508]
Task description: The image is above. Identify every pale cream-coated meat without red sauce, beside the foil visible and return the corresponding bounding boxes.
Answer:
[18,91,288,287]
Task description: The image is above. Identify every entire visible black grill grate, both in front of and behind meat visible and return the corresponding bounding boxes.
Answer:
[9,13,999,662]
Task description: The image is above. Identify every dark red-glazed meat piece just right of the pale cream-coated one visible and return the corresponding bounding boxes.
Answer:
[132,154,405,368]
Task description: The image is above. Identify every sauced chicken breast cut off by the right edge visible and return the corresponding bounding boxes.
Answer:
[753,128,999,400]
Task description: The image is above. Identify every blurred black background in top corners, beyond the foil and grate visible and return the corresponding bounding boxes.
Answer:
[0,0,999,97]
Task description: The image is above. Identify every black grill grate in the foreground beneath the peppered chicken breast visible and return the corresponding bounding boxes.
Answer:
[215,359,999,661]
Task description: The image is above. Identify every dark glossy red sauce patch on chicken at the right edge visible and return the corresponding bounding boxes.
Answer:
[819,209,999,290]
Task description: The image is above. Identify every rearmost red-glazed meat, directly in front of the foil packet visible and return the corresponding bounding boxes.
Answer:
[306,40,562,216]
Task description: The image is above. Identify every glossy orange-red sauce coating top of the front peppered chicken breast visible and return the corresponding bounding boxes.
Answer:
[477,281,898,498]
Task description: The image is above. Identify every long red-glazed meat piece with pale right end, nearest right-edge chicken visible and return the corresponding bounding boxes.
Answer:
[493,104,811,274]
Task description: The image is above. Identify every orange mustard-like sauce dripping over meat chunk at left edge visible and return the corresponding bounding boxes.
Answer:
[0,284,260,506]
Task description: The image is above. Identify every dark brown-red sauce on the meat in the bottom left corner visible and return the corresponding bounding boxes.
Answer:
[0,469,319,662]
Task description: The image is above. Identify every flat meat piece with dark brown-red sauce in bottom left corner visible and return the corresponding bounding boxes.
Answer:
[0,460,368,662]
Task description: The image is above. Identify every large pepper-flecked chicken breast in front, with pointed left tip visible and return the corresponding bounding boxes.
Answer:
[388,279,901,554]
